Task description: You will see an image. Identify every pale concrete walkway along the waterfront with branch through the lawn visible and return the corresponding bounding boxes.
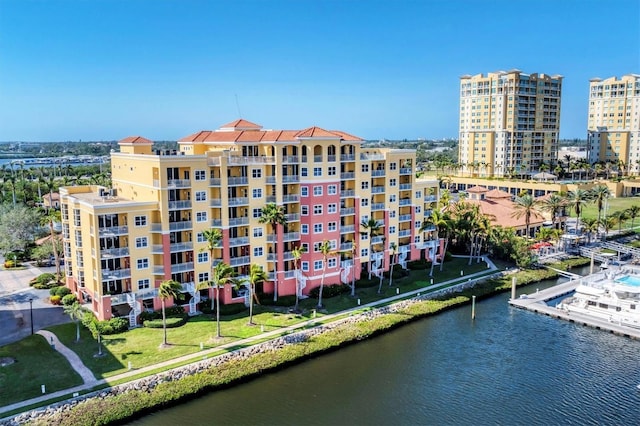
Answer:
[0,257,499,416]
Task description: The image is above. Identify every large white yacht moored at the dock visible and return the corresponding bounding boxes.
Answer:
[557,265,640,328]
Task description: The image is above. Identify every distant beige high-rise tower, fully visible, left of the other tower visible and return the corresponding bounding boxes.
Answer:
[458,70,562,176]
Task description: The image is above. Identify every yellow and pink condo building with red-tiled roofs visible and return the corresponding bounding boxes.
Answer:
[60,119,441,326]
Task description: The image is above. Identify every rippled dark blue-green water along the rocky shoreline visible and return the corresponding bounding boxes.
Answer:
[131,269,640,426]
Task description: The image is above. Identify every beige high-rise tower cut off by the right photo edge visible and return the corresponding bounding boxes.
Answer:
[587,74,640,173]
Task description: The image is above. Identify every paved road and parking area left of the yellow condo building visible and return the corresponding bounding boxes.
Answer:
[0,265,69,346]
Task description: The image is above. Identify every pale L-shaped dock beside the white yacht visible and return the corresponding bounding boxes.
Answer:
[509,280,640,340]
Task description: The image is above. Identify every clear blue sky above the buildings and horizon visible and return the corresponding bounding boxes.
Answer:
[0,0,640,141]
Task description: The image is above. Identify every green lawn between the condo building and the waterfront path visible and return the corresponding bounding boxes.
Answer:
[0,258,490,406]
